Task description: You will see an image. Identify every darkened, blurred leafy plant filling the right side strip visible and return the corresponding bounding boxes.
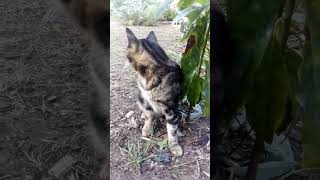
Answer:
[215,0,320,180]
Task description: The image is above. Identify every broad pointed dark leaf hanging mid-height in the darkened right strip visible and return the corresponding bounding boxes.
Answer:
[246,38,289,143]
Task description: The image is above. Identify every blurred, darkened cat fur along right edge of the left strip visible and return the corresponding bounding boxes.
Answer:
[57,0,110,179]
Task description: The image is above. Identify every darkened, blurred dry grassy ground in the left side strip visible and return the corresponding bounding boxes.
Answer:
[0,0,102,180]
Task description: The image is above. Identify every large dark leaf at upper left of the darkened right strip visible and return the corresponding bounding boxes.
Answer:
[224,0,281,121]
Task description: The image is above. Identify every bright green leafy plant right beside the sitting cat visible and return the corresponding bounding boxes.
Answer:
[157,0,210,120]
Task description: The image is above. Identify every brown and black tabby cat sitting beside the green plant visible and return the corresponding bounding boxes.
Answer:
[126,28,183,156]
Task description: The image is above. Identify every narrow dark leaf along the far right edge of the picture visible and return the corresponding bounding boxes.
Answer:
[302,0,320,167]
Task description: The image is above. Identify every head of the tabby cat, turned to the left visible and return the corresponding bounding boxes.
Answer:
[126,28,169,70]
